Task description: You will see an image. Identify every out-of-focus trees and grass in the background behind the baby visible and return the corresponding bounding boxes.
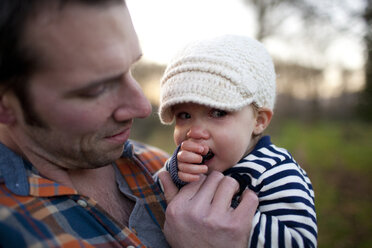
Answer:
[131,0,372,248]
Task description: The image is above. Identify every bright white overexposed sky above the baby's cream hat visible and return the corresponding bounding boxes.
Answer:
[127,0,363,69]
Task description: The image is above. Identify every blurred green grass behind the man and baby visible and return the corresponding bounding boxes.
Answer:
[134,120,372,248]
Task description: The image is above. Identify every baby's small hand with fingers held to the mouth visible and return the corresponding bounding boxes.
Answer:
[177,140,209,183]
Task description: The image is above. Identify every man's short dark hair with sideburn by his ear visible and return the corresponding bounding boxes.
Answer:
[0,0,125,126]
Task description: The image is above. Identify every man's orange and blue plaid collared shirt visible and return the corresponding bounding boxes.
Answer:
[0,141,167,247]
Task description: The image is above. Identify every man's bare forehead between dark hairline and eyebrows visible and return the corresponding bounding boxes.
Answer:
[23,1,141,90]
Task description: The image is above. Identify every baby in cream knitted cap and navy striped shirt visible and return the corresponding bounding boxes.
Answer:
[159,35,317,247]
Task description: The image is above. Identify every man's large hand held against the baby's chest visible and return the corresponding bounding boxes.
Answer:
[159,172,258,248]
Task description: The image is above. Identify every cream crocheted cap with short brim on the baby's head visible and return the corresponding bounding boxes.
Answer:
[159,35,276,124]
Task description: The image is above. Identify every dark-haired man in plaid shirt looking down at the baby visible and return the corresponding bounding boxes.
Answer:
[0,0,257,247]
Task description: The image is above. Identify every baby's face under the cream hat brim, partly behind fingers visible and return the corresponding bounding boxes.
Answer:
[172,103,256,173]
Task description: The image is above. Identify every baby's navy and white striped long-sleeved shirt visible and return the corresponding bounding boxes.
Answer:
[165,136,318,247]
